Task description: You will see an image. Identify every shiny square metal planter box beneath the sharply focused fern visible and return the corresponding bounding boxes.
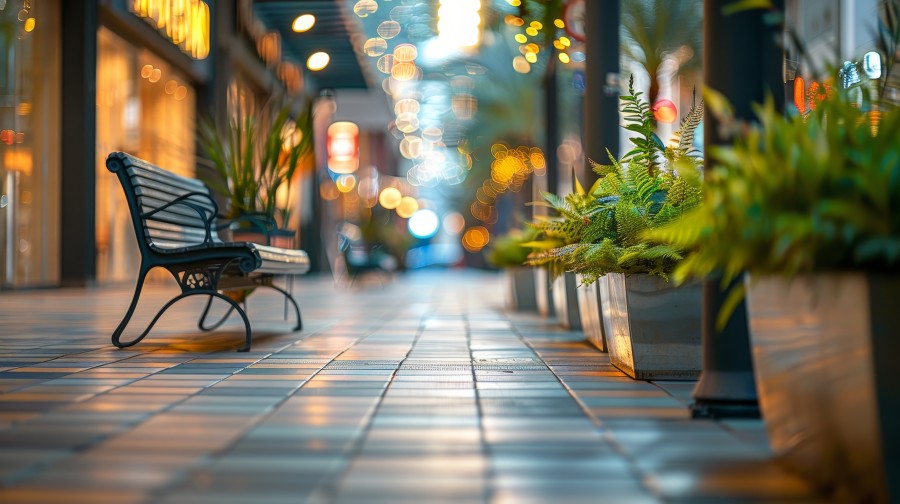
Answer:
[599,273,703,380]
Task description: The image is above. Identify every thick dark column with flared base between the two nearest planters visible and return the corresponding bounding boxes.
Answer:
[693,0,784,417]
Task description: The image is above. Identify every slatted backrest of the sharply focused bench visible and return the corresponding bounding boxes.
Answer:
[106,152,221,252]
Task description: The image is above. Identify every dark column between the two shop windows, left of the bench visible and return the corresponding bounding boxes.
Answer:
[60,0,98,286]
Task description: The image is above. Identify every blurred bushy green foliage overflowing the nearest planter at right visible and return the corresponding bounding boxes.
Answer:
[644,89,900,281]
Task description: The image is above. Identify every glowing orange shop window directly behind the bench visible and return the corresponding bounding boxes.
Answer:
[96,27,196,282]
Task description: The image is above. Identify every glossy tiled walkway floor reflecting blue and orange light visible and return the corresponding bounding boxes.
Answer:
[0,271,821,504]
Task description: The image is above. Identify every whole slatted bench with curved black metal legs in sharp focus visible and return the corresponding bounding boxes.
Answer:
[106,152,309,352]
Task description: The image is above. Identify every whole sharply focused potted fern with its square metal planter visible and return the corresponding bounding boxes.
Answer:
[535,80,702,379]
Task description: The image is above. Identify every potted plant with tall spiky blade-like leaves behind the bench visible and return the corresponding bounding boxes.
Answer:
[200,95,313,248]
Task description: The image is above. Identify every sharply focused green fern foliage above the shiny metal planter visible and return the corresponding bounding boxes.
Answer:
[528,79,703,283]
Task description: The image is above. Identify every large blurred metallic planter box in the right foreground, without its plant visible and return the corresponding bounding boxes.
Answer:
[747,273,900,503]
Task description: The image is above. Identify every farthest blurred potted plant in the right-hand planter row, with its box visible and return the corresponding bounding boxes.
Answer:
[485,227,537,311]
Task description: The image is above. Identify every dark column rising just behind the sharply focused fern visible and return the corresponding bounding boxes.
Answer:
[579,0,620,183]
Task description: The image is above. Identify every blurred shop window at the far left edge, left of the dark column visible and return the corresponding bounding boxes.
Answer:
[0,0,61,286]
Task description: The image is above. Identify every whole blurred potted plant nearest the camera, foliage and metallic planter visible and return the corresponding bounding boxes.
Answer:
[653,86,900,502]
